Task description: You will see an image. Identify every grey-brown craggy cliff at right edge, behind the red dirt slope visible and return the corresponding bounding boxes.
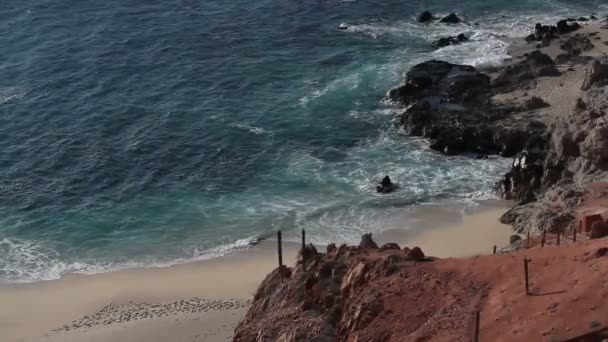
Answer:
[499,57,608,232]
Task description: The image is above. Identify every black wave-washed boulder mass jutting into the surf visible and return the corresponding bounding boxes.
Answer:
[388,58,557,156]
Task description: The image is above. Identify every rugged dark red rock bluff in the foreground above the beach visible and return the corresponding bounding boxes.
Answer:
[234,235,483,342]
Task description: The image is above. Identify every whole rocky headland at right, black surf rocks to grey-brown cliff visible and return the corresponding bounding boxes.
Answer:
[387,16,608,240]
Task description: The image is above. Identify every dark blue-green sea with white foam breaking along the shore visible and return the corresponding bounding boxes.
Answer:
[0,0,601,281]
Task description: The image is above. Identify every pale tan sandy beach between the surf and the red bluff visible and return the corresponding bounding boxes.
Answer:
[0,202,512,342]
